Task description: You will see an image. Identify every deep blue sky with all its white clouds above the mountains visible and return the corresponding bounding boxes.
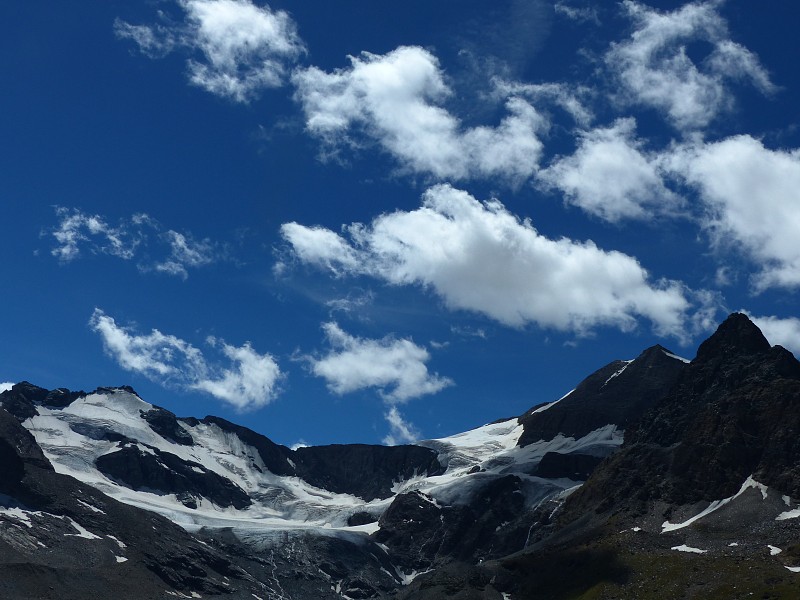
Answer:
[0,0,800,445]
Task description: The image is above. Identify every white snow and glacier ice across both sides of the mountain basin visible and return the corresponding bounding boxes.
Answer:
[23,388,622,533]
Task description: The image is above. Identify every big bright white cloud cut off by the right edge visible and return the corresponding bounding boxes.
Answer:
[667,135,800,291]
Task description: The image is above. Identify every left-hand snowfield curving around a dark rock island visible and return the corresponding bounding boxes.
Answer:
[23,388,386,529]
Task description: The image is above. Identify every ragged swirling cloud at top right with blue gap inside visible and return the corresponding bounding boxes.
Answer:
[605,0,774,131]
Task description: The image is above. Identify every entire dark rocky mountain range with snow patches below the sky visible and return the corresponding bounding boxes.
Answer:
[0,314,800,600]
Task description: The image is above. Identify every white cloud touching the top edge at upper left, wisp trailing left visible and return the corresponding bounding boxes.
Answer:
[115,0,305,102]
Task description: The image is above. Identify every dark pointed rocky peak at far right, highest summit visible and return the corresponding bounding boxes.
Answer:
[566,314,800,517]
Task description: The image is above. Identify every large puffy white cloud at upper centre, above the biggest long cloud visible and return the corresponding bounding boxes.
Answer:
[293,46,547,184]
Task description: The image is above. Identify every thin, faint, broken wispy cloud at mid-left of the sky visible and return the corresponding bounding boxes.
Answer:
[46,207,224,279]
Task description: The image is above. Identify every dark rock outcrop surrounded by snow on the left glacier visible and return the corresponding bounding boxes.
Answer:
[96,446,251,509]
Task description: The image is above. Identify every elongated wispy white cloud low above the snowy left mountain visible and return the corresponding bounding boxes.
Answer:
[89,308,282,410]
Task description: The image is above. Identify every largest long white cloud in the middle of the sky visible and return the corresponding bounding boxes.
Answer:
[282,185,689,337]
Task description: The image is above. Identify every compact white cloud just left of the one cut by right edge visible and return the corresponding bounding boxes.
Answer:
[539,118,681,222]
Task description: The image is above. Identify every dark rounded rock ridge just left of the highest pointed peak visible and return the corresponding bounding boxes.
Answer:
[519,346,687,446]
